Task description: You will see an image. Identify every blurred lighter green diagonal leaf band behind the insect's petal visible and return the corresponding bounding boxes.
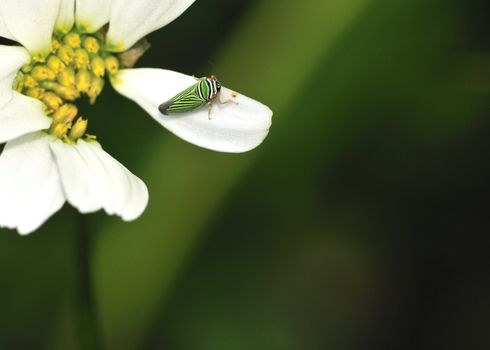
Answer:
[89,0,367,349]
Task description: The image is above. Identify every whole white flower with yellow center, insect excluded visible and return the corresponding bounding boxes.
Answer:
[0,0,272,234]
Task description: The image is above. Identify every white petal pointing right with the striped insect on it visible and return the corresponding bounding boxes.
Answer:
[112,69,272,153]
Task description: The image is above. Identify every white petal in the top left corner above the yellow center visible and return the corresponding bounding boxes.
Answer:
[0,0,60,55]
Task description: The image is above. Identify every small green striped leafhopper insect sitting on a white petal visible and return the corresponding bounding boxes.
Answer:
[158,76,221,115]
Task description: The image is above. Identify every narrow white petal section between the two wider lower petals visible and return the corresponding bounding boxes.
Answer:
[50,140,102,214]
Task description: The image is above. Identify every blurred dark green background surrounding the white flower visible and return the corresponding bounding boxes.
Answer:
[0,0,490,350]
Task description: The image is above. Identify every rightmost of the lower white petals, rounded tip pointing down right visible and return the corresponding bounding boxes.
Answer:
[76,140,148,221]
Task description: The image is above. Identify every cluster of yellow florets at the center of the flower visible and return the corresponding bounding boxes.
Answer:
[14,30,120,143]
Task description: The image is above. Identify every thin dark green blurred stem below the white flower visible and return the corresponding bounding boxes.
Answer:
[75,213,101,350]
